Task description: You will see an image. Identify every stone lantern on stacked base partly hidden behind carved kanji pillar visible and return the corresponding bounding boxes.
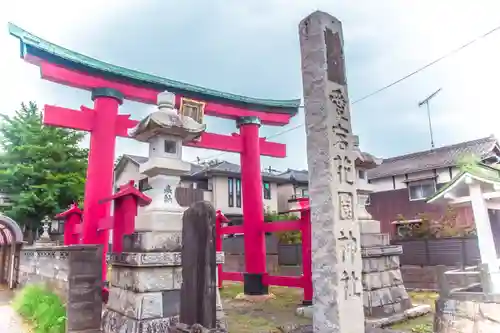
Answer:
[354,137,412,322]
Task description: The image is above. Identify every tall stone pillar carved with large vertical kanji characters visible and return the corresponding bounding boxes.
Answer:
[299,11,365,333]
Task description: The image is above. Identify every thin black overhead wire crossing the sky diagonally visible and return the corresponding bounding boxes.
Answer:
[192,21,500,161]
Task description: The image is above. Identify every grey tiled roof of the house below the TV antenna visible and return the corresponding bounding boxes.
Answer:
[368,135,498,179]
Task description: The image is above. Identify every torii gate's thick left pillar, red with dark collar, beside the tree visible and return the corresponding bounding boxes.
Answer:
[82,88,123,281]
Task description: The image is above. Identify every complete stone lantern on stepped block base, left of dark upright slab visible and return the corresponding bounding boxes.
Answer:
[103,92,220,333]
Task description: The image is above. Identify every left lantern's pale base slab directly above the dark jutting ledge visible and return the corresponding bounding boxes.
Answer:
[123,231,182,252]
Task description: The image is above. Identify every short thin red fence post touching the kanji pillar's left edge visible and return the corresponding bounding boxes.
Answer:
[300,207,313,305]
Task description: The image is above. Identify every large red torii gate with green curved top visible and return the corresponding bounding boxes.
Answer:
[9,24,300,294]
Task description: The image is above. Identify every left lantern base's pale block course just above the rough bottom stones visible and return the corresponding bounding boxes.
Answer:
[108,287,180,320]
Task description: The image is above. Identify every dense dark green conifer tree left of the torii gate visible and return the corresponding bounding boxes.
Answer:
[0,102,88,235]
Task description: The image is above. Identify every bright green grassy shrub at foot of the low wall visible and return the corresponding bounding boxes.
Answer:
[12,285,66,333]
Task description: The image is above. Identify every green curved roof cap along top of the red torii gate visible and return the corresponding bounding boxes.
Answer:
[9,23,300,115]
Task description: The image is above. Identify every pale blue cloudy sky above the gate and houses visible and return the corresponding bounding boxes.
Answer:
[0,0,500,169]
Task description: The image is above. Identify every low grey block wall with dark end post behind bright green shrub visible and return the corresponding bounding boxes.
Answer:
[18,245,102,333]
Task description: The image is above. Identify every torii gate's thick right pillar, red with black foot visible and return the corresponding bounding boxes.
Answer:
[236,117,268,295]
